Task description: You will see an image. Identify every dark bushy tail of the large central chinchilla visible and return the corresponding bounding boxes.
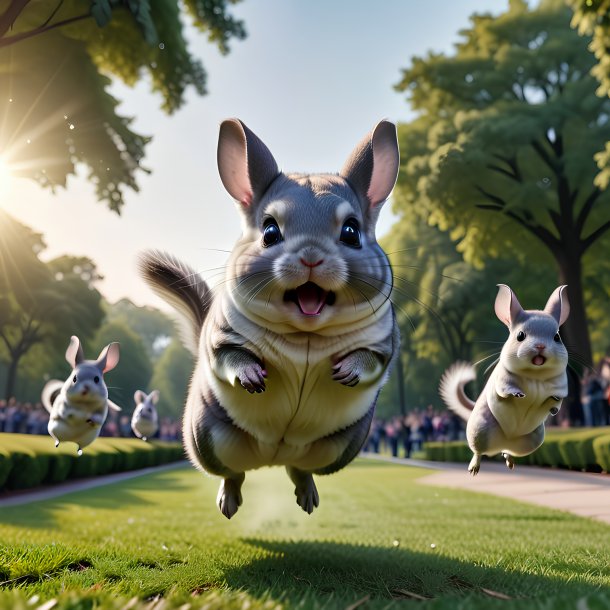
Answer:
[139,250,212,355]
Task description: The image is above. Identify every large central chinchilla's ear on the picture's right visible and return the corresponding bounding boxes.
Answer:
[341,120,400,221]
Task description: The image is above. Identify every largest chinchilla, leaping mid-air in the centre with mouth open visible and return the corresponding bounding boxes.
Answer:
[140,119,399,518]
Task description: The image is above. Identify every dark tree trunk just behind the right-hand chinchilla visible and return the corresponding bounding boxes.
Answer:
[557,252,593,375]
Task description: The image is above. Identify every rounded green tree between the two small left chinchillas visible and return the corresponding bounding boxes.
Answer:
[90,322,152,408]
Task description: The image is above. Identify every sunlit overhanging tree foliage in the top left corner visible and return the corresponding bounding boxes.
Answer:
[0,0,245,213]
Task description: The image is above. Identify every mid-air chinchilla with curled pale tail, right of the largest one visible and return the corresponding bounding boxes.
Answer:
[439,284,570,475]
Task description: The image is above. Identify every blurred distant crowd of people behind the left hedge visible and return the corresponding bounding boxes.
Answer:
[0,398,181,441]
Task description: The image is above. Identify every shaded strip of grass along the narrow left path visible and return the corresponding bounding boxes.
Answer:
[0,466,189,529]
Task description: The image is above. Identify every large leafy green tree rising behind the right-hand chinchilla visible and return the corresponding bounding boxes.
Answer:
[396,0,610,361]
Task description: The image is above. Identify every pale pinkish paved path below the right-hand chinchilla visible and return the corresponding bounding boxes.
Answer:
[366,454,610,524]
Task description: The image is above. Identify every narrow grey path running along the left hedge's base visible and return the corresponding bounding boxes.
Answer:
[0,461,189,509]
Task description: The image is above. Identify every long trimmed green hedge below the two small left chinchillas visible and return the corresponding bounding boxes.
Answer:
[0,432,185,491]
